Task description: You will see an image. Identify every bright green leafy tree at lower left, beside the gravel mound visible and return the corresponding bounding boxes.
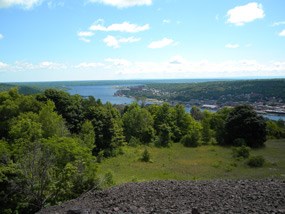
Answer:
[10,137,97,212]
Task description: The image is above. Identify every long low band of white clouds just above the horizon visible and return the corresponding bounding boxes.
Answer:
[3,56,285,81]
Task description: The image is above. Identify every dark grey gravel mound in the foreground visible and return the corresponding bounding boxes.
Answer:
[39,180,285,214]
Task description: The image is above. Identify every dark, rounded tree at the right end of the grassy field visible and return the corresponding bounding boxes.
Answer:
[225,105,266,147]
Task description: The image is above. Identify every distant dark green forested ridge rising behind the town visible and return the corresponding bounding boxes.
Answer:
[117,79,285,103]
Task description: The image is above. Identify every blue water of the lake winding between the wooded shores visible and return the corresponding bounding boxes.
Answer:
[68,82,285,121]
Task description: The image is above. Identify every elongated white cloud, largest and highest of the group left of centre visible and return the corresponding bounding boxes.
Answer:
[89,19,150,33]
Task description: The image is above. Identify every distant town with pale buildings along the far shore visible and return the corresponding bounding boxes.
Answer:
[114,85,285,115]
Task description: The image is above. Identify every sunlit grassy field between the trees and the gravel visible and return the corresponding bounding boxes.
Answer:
[98,139,285,184]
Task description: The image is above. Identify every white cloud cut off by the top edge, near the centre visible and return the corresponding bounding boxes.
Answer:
[89,0,152,8]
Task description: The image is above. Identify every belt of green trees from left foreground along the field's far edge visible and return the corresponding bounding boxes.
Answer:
[0,88,285,213]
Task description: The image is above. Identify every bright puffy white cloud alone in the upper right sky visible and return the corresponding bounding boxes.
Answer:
[227,2,265,26]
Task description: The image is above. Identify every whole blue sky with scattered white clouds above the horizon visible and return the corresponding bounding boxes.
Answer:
[0,0,285,82]
